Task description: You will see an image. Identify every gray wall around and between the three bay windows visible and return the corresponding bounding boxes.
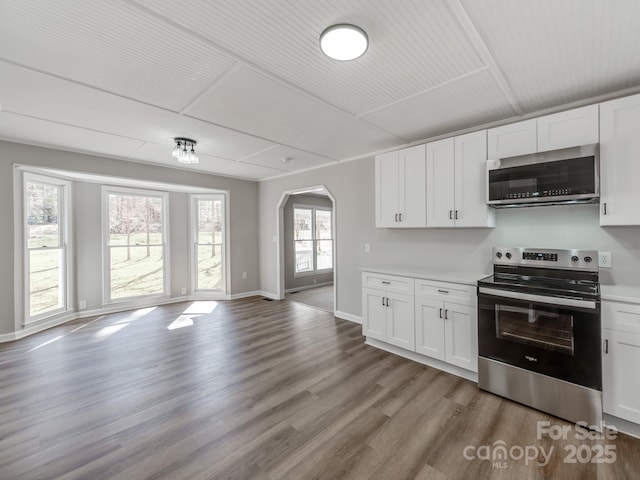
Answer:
[0,141,260,334]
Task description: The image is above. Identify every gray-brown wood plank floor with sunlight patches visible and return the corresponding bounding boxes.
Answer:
[0,297,640,480]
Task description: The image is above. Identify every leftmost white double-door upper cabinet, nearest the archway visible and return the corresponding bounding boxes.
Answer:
[375,145,427,228]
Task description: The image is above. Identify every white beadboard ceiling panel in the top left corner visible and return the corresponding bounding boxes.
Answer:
[0,0,235,111]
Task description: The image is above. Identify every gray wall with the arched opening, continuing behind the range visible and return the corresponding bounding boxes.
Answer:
[259,157,640,316]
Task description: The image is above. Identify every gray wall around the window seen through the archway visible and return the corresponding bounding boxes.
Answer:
[283,194,333,290]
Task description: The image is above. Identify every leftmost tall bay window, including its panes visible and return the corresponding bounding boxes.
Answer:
[24,173,70,321]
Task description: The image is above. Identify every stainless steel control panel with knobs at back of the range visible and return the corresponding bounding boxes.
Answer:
[493,247,598,272]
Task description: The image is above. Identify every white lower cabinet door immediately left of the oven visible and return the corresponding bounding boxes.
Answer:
[444,303,478,372]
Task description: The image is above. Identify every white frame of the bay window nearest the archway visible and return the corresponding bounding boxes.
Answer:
[189,191,230,297]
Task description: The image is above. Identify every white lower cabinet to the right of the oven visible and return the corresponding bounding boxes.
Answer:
[602,301,640,424]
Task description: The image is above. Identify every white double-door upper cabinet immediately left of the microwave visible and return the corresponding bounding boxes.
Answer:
[427,130,495,227]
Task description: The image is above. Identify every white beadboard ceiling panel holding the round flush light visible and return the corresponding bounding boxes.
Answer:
[136,0,483,114]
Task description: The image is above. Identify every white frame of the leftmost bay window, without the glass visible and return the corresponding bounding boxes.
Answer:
[21,170,75,326]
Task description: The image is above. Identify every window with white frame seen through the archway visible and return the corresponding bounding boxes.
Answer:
[293,206,333,274]
